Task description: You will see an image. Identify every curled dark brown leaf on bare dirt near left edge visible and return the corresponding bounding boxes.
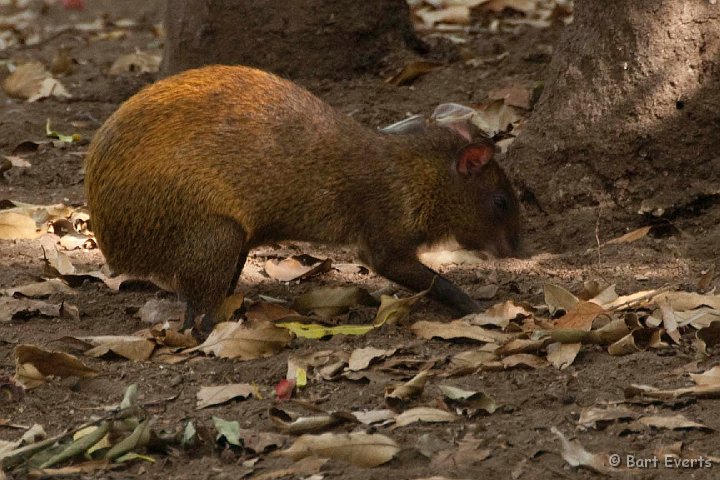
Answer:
[15,345,97,389]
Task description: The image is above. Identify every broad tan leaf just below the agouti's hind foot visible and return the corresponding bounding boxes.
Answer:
[194,322,291,360]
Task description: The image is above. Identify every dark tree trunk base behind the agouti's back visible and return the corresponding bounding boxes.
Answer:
[163,0,422,78]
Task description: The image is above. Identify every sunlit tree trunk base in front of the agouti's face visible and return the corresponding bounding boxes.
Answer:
[508,0,720,215]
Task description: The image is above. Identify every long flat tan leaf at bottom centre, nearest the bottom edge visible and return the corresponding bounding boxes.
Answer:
[280,432,400,468]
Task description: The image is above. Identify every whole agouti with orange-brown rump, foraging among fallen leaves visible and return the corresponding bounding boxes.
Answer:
[85,66,520,332]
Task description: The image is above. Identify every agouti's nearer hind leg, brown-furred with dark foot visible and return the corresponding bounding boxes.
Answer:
[176,217,246,334]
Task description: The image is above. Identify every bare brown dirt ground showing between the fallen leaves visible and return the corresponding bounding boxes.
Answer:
[0,0,720,479]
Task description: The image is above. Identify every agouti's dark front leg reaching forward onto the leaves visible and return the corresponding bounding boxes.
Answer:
[361,250,480,315]
